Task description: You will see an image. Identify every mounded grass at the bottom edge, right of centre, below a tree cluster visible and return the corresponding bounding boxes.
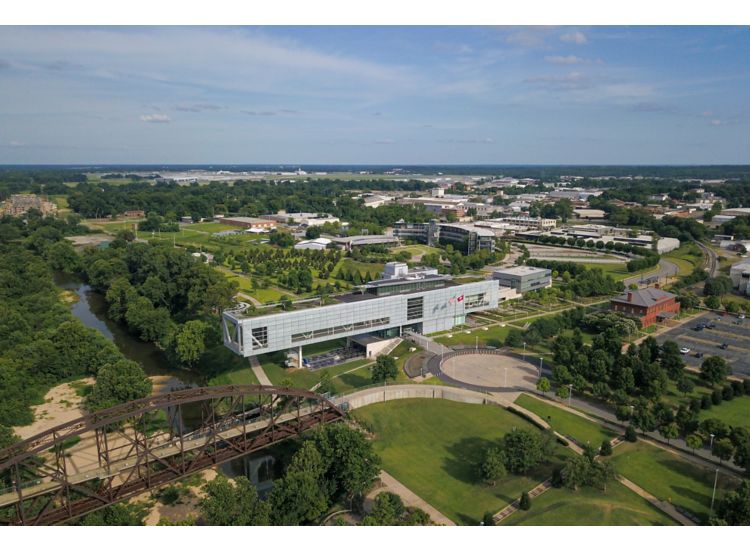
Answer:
[501,482,679,526]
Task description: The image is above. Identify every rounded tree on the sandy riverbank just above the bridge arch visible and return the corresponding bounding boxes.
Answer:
[86,359,151,411]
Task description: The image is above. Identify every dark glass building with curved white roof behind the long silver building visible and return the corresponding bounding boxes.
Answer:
[393,220,495,254]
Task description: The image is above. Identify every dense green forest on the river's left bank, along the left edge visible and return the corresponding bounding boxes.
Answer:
[0,215,151,436]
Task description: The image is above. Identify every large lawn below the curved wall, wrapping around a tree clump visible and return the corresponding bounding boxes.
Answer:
[354,399,571,525]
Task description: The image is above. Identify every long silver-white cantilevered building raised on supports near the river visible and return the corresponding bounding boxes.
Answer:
[223,262,499,363]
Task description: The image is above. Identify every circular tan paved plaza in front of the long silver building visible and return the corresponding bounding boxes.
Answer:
[438,353,539,392]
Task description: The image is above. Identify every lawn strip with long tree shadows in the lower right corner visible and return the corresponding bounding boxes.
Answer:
[612,442,736,522]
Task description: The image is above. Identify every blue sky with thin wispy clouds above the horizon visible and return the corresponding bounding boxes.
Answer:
[0,26,750,164]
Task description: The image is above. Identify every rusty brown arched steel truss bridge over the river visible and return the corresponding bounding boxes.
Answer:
[0,385,344,525]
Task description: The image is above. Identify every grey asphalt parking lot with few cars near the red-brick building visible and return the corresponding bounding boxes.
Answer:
[656,313,750,377]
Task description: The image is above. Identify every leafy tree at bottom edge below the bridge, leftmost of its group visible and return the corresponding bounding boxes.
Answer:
[199,475,270,526]
